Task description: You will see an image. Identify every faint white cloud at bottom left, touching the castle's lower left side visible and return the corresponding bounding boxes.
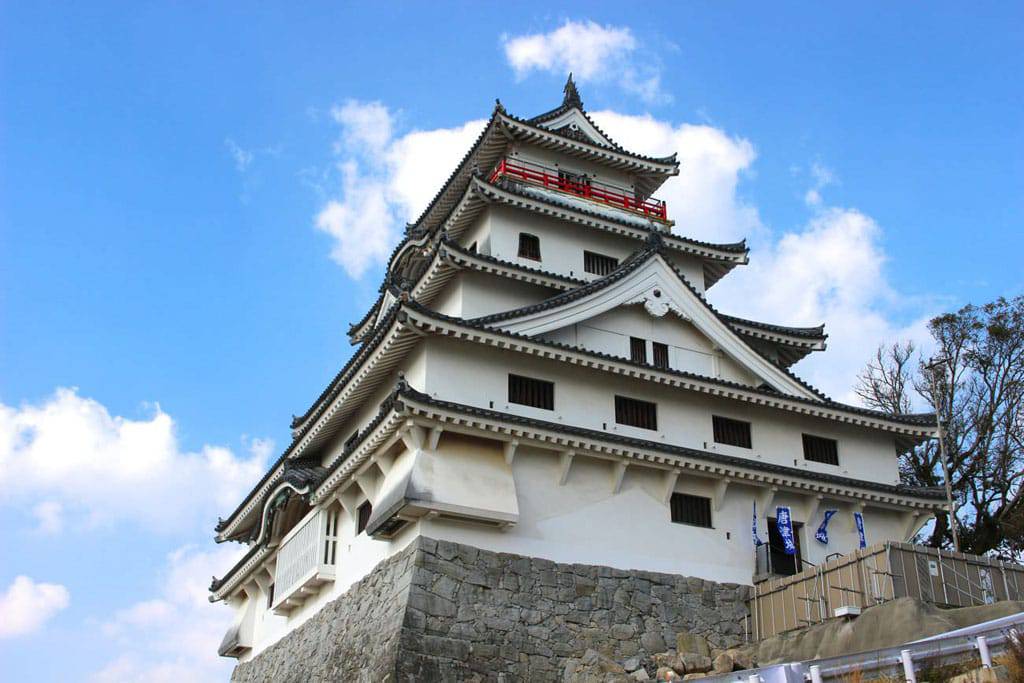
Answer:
[90,546,239,683]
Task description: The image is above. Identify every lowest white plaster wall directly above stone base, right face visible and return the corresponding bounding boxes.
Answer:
[421,446,902,584]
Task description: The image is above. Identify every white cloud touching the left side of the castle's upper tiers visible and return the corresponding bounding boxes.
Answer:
[315,100,485,279]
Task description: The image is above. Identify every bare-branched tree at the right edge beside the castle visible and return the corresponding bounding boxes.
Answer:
[857,297,1024,556]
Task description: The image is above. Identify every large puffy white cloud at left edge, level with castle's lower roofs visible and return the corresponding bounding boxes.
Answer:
[0,388,270,532]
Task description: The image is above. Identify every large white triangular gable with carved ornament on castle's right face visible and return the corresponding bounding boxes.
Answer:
[494,253,818,399]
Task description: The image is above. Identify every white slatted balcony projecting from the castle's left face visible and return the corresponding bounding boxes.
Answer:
[271,508,338,614]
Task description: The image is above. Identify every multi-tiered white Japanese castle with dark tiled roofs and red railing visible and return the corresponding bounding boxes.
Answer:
[211,77,943,680]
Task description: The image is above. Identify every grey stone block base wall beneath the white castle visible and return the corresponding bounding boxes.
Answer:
[232,538,749,682]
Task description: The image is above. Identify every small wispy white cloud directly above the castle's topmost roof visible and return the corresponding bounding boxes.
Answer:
[502,20,668,101]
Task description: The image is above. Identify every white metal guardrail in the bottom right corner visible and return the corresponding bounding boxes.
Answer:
[701,612,1024,683]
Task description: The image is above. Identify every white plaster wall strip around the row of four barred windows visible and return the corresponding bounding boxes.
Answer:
[426,339,899,483]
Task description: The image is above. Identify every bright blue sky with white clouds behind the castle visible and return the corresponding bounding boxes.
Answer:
[0,2,1024,681]
